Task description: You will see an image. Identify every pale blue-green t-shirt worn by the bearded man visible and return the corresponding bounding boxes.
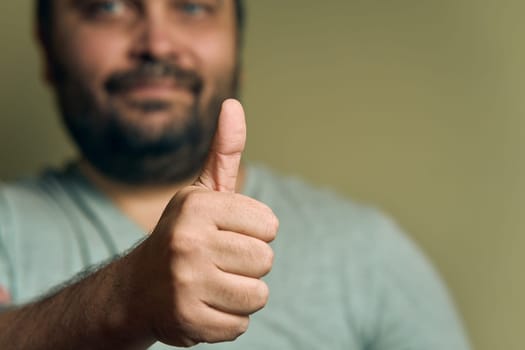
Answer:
[0,166,469,350]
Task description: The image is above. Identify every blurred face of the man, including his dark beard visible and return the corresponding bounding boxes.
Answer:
[47,0,238,183]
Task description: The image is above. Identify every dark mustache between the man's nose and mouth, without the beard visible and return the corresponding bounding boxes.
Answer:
[105,61,203,94]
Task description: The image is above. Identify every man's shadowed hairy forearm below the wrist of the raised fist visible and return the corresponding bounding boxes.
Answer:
[0,254,153,350]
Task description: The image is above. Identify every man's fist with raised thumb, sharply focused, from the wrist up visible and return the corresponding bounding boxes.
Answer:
[130,100,278,346]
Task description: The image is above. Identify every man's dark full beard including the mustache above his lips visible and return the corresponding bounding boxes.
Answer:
[54,60,238,185]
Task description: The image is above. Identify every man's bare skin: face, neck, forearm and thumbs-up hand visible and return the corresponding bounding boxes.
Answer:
[0,0,278,350]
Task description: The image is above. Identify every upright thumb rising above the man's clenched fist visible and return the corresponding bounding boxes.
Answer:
[195,99,246,192]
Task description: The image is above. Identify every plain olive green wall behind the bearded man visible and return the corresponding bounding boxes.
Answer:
[0,0,525,350]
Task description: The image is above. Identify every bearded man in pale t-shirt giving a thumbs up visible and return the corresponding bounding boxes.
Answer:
[0,0,468,350]
